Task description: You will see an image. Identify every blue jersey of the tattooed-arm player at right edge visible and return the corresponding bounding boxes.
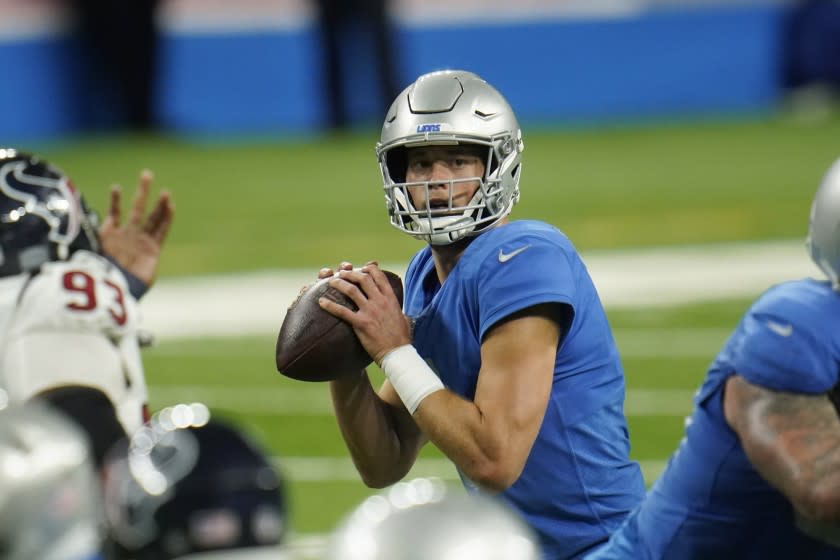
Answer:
[591,280,840,560]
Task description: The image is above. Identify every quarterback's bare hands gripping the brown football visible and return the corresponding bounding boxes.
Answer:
[320,262,411,364]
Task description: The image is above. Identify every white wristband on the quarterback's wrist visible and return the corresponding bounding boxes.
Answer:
[380,344,444,414]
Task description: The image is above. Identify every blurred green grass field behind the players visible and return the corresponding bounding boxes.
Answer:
[26,112,840,548]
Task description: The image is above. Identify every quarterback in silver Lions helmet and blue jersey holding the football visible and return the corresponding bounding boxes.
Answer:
[319,71,644,559]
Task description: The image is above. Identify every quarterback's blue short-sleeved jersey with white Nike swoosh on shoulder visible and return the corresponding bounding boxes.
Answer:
[405,221,644,560]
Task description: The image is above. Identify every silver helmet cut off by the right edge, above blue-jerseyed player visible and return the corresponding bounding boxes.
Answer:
[807,159,840,291]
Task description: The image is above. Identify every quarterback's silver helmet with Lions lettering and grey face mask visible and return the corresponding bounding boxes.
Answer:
[376,70,524,245]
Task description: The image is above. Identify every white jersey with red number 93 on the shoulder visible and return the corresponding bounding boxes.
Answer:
[0,251,148,434]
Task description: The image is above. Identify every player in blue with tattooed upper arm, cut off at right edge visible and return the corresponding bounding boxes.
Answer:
[592,160,840,560]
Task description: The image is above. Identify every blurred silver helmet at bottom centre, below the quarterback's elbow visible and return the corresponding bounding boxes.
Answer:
[327,478,541,560]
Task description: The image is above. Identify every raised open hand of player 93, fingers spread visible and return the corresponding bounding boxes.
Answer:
[99,169,175,286]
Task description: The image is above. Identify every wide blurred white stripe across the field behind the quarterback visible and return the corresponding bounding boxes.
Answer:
[141,240,822,341]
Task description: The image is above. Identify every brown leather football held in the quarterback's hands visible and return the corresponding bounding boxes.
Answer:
[275,270,403,381]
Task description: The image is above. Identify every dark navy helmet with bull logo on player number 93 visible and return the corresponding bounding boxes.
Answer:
[0,148,99,277]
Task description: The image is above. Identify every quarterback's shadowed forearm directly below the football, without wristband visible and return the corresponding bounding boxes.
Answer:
[330,371,419,488]
